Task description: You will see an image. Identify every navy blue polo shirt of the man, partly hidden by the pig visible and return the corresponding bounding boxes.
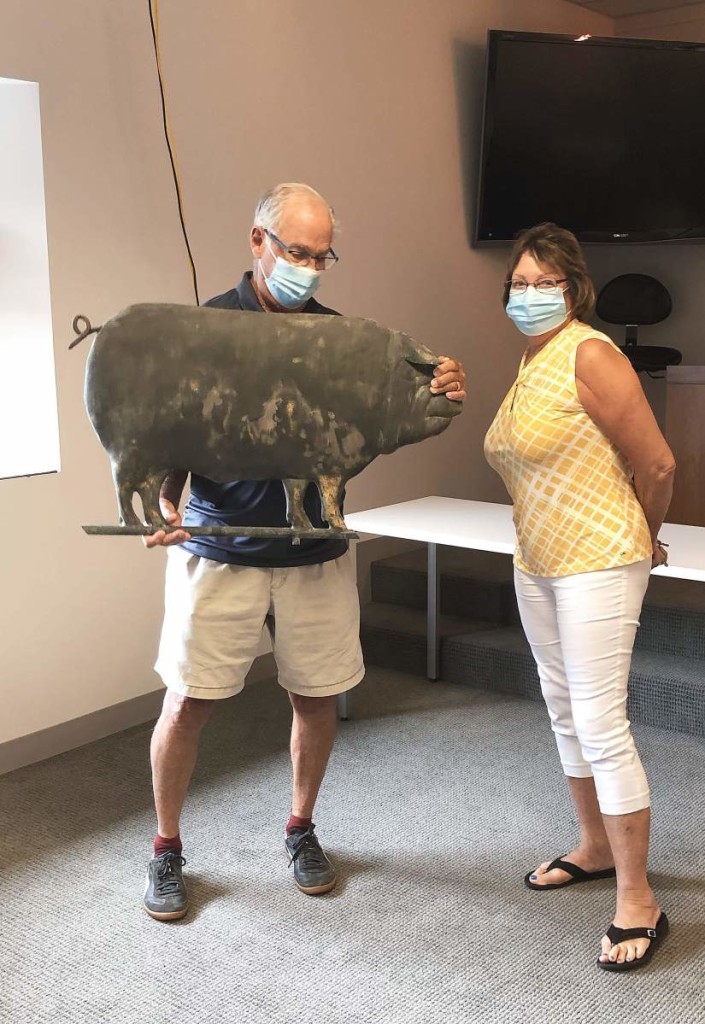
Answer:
[182,271,347,568]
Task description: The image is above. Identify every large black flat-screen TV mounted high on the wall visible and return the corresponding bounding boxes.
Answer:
[474,31,705,244]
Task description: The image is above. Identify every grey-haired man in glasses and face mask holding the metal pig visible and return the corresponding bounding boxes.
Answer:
[144,183,465,921]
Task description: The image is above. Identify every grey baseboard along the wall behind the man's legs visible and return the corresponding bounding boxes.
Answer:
[0,654,277,775]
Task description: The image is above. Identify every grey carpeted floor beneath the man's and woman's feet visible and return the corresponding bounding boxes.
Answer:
[0,670,705,1024]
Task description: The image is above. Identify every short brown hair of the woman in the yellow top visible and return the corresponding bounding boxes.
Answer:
[502,222,595,322]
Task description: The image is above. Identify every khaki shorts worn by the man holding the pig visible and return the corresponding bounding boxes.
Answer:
[155,547,365,700]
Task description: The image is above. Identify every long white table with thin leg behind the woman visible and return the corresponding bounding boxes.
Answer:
[345,497,705,679]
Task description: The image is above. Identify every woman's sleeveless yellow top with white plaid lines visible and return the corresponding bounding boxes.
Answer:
[485,321,652,577]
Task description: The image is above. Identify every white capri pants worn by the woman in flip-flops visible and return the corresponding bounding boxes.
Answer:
[514,558,651,814]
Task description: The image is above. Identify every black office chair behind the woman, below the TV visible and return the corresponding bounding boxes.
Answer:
[595,273,682,377]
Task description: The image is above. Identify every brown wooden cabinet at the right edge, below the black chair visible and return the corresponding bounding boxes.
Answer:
[665,366,705,526]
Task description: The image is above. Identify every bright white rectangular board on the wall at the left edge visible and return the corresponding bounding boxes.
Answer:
[0,78,59,477]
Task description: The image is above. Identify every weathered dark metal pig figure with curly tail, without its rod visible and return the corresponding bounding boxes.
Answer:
[72,303,461,534]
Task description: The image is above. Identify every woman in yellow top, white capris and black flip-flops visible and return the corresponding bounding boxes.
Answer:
[485,223,675,971]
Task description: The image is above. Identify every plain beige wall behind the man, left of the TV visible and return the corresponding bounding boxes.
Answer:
[0,0,659,741]
